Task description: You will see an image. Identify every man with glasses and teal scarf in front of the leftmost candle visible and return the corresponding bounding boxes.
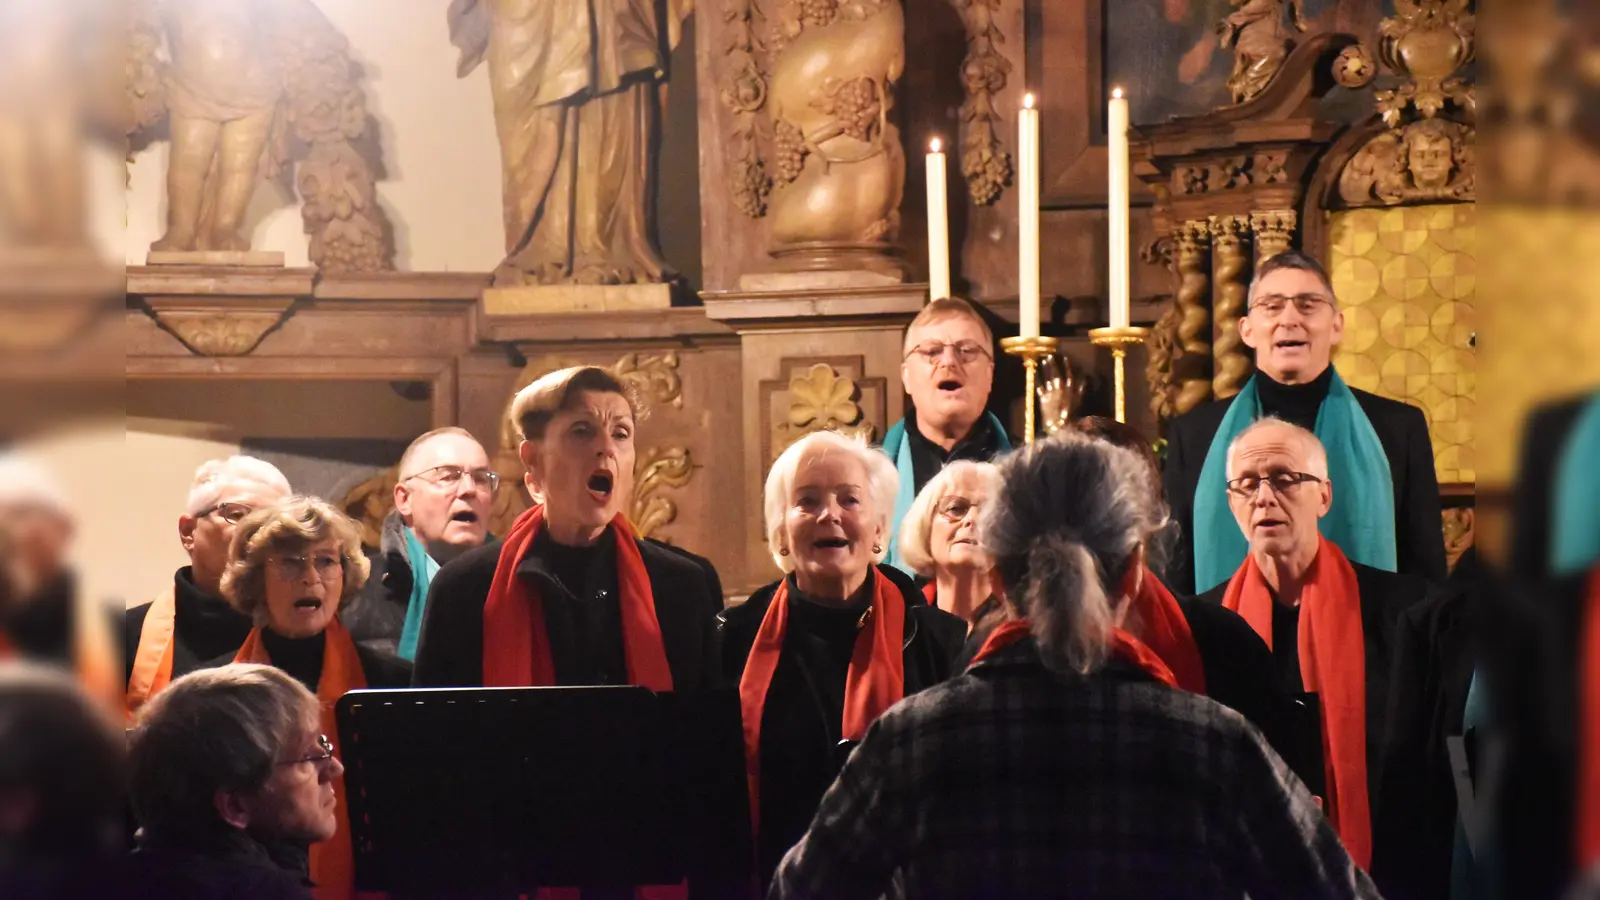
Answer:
[883,298,1011,573]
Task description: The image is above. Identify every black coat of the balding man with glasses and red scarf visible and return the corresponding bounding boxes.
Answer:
[1198,562,1430,833]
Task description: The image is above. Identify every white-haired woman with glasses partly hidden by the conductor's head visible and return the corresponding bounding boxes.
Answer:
[899,460,1000,626]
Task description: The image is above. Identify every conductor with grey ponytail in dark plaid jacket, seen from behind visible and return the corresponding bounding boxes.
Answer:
[770,432,1378,900]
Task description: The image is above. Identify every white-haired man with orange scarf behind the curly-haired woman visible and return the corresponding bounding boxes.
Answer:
[123,456,290,716]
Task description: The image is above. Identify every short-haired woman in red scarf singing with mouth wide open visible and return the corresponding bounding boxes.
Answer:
[416,365,722,693]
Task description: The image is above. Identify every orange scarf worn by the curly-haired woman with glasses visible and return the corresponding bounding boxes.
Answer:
[233,610,371,900]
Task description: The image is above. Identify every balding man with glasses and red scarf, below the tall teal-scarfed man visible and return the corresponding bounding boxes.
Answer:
[1200,418,1429,868]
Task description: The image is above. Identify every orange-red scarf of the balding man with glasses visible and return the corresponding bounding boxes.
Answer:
[1222,538,1373,870]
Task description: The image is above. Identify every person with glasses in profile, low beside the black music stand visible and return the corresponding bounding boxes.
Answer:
[128,665,344,900]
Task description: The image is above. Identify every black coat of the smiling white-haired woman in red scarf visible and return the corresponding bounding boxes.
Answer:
[720,565,966,884]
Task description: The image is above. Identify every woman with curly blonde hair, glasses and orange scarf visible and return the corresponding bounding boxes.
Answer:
[222,496,411,900]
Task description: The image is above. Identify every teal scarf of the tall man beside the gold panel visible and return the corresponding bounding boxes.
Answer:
[1194,372,1397,593]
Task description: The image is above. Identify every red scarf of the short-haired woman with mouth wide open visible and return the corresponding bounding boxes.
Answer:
[483,504,688,900]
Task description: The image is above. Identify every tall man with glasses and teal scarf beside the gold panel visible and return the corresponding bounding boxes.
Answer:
[1163,251,1445,593]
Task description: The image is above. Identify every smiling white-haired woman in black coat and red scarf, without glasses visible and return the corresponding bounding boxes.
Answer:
[722,431,966,884]
